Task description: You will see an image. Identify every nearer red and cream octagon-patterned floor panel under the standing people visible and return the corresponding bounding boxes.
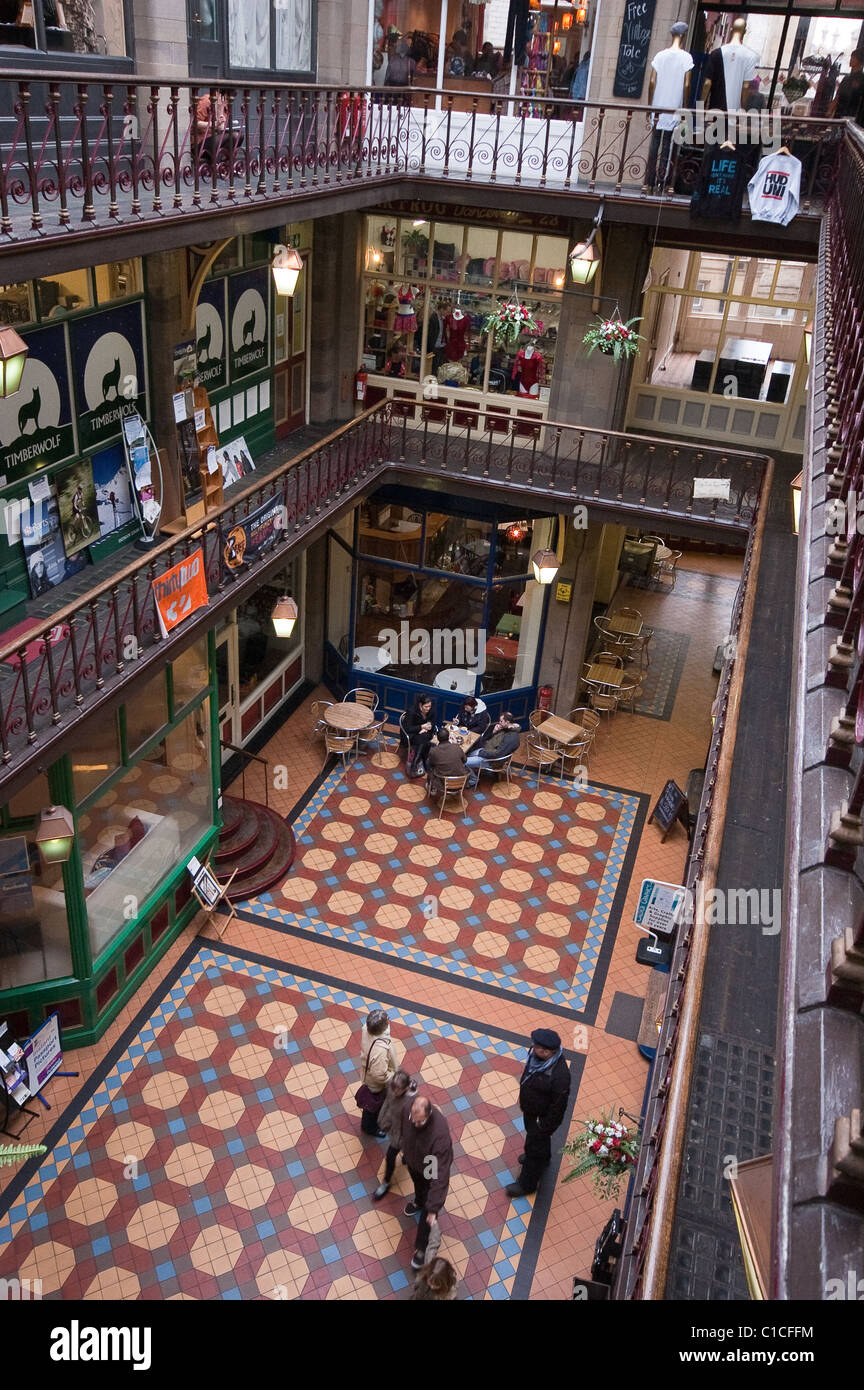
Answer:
[0,938,581,1300]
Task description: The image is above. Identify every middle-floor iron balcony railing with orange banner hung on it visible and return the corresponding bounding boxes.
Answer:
[0,402,768,798]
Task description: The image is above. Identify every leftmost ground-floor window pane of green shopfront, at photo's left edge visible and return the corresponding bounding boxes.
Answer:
[0,822,72,990]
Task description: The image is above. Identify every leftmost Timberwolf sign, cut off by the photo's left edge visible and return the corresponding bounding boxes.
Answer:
[0,324,75,482]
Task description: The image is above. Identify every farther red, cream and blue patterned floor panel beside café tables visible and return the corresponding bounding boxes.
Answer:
[240,753,645,1013]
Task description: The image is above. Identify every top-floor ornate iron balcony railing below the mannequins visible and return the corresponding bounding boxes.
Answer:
[0,74,845,252]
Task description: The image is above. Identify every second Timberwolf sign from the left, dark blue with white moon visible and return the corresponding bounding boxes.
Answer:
[69,304,147,449]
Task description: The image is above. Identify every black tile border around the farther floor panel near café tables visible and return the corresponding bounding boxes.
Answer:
[236,767,650,1026]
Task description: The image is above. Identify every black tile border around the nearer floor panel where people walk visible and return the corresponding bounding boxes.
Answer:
[0,935,585,1302]
